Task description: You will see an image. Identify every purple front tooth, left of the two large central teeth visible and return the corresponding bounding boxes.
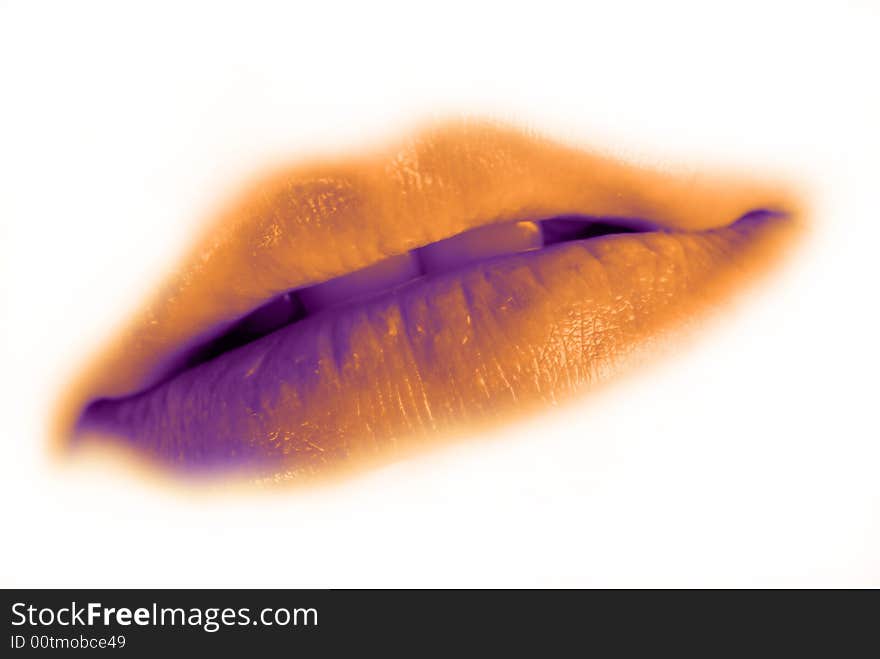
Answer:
[298,252,421,313]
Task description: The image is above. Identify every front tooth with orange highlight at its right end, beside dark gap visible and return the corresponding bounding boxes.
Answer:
[417,222,543,274]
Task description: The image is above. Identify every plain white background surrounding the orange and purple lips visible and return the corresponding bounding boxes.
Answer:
[0,0,880,587]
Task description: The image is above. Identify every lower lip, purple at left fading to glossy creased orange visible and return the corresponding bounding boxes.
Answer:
[80,213,790,477]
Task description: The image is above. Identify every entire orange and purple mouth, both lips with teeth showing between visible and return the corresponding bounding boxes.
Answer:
[59,124,799,479]
